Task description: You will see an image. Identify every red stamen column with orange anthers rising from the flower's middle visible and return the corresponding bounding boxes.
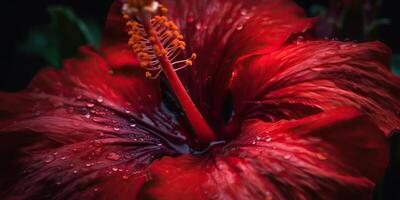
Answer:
[122,0,216,143]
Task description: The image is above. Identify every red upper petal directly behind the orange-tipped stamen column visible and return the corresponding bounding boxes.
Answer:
[102,0,314,121]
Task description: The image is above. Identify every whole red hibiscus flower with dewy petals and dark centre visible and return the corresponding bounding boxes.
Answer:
[0,0,400,200]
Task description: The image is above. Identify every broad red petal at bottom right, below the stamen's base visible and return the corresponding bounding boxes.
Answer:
[143,107,388,199]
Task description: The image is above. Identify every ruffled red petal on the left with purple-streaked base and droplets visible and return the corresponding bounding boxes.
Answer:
[0,48,188,199]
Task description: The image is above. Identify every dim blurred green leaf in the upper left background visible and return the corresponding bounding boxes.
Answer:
[20,6,100,68]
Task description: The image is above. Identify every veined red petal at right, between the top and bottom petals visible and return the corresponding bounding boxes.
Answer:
[231,41,400,134]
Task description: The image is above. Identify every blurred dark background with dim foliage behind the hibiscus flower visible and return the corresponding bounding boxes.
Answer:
[0,0,400,199]
